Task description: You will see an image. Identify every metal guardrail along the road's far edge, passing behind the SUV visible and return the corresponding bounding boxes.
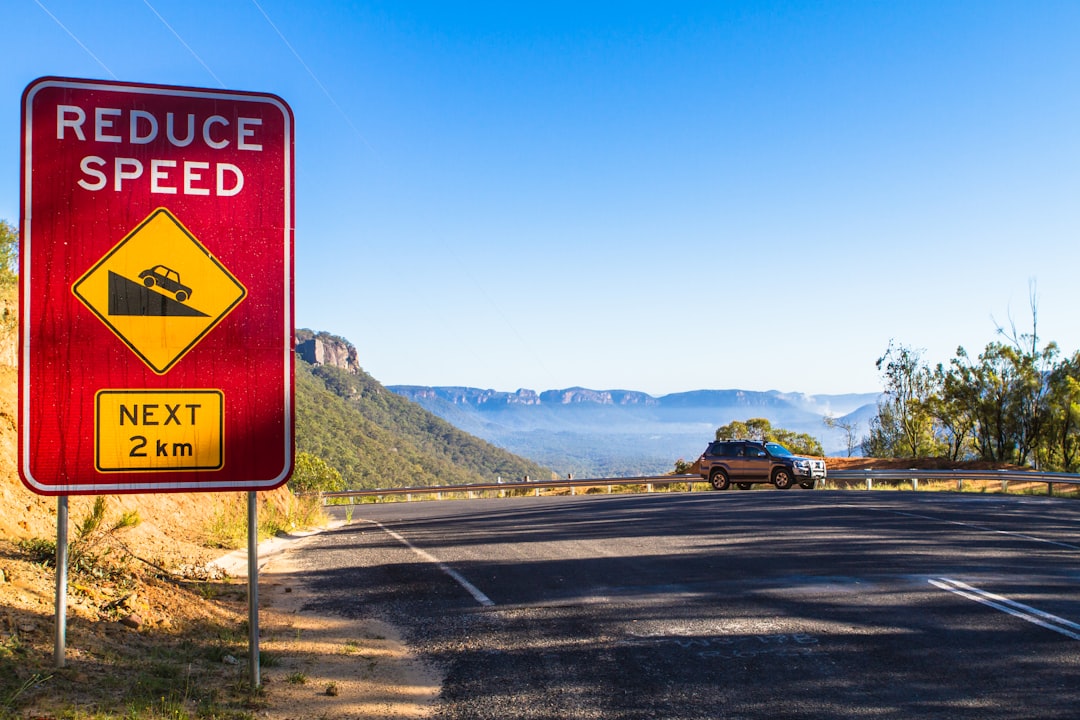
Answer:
[322,467,1080,503]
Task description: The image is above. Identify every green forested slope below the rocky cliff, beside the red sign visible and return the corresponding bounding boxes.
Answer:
[296,332,551,489]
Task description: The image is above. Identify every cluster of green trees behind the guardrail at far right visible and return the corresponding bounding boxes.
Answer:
[862,289,1080,473]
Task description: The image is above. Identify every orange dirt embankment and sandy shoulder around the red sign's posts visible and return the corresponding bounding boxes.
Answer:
[0,323,440,720]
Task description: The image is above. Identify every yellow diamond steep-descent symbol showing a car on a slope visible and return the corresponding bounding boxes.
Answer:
[71,207,247,375]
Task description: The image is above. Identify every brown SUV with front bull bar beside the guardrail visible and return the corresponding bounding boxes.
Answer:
[699,440,825,490]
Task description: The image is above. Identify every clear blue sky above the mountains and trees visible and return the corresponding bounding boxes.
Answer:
[0,0,1080,395]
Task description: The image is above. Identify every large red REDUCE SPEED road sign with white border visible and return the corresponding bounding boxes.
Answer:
[18,78,293,494]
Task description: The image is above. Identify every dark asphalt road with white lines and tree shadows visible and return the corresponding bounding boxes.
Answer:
[287,490,1080,720]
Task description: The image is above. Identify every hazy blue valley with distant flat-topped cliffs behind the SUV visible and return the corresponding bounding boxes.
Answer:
[388,385,880,479]
